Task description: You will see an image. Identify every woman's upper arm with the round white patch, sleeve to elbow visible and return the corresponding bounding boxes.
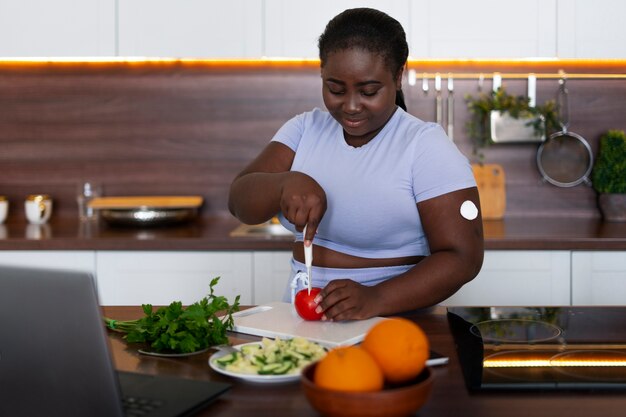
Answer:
[417,187,484,279]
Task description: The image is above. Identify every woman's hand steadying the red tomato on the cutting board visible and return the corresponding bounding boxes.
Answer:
[318,279,380,321]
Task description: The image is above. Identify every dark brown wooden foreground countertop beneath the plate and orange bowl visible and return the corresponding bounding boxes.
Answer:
[103,307,626,417]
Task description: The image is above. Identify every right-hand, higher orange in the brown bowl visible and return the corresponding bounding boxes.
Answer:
[361,318,429,383]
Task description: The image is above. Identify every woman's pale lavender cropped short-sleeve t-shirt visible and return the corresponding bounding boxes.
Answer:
[272,108,476,258]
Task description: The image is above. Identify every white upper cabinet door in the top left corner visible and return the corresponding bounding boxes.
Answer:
[0,0,116,57]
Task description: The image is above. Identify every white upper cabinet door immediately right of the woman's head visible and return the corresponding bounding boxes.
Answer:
[409,0,557,58]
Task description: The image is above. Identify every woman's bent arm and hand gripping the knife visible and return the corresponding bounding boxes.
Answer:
[228,142,326,236]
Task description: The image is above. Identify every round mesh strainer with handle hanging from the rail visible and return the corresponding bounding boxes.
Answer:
[537,75,593,187]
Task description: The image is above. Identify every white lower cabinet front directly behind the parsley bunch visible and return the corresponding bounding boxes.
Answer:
[96,251,252,305]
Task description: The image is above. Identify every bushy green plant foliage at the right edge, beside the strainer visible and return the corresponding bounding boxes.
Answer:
[591,130,626,194]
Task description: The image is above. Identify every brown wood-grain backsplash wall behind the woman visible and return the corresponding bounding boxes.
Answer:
[0,61,626,221]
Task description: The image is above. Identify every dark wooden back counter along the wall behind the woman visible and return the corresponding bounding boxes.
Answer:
[0,215,626,251]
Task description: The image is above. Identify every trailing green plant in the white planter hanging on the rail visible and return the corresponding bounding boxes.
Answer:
[465,87,559,161]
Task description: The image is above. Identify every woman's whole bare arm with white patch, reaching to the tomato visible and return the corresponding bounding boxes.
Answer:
[320,187,484,320]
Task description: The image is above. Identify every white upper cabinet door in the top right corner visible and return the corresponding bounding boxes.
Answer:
[556,0,626,59]
